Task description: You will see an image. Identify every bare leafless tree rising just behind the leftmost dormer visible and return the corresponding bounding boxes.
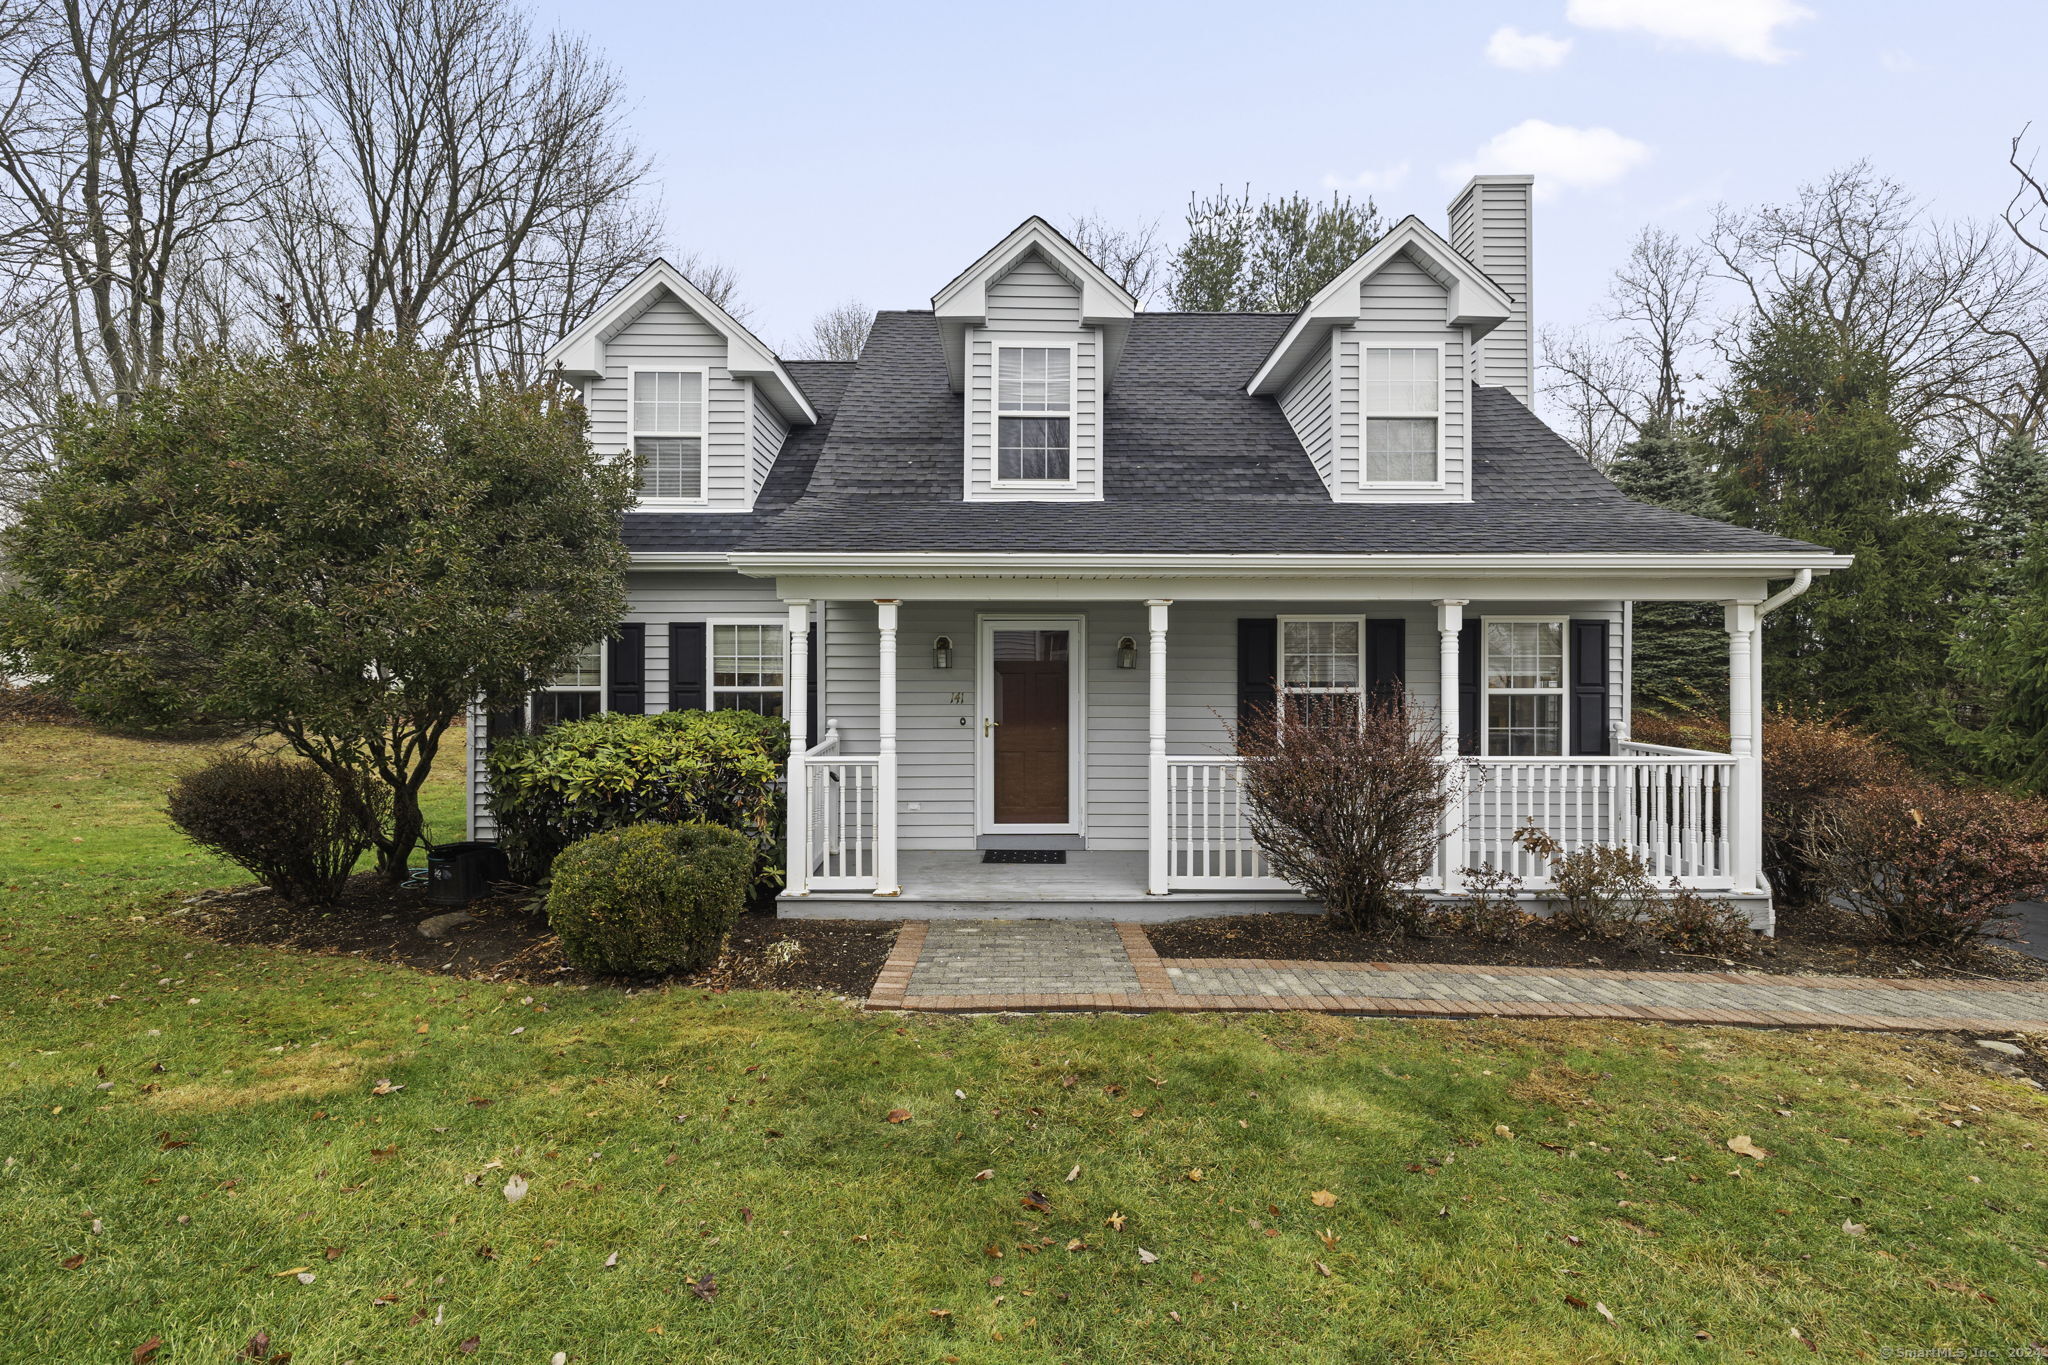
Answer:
[282,0,657,368]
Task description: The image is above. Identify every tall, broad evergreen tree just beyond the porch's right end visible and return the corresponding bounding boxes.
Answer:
[1702,295,1966,755]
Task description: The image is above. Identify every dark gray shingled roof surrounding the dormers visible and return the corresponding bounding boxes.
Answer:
[627,313,1817,555]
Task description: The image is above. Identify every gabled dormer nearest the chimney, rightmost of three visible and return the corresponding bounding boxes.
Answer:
[1247,200,1528,501]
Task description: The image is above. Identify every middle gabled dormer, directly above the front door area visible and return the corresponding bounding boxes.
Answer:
[932,217,1137,501]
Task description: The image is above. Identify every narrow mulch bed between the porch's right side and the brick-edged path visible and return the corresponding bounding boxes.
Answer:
[1145,913,2048,980]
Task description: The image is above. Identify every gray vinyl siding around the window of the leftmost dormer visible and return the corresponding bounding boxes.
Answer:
[584,293,768,512]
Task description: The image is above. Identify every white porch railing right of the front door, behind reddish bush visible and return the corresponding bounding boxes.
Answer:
[1165,743,1735,890]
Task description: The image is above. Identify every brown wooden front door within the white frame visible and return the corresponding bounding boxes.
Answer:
[989,626,1073,825]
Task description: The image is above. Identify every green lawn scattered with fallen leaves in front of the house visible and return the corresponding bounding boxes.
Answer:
[0,729,2048,1365]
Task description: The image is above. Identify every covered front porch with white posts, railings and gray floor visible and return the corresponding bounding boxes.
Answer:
[778,564,1769,927]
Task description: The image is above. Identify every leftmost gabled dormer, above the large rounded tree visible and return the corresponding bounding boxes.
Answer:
[545,260,817,512]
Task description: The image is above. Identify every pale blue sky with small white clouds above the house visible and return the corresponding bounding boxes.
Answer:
[537,0,2048,344]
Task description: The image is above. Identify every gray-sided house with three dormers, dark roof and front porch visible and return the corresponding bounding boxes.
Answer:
[471,176,1849,925]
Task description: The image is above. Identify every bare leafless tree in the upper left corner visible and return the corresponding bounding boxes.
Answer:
[0,0,289,407]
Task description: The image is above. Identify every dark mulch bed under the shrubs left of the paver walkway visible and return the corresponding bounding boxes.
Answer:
[176,874,899,997]
